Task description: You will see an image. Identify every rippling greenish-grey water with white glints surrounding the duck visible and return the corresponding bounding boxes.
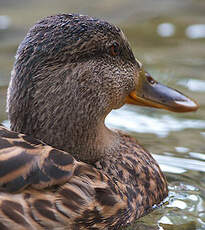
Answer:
[0,0,205,230]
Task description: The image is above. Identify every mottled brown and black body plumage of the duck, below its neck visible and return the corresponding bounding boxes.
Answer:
[0,126,167,229]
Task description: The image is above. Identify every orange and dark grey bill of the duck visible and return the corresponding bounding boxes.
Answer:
[126,70,199,112]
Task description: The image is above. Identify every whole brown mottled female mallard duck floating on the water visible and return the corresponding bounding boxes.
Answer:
[0,14,198,230]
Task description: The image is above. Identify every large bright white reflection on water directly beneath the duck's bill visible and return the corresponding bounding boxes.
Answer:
[106,106,205,137]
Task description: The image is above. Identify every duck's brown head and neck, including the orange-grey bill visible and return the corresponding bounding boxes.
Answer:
[7,14,198,162]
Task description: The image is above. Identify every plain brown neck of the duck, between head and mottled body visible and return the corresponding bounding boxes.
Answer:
[27,105,119,163]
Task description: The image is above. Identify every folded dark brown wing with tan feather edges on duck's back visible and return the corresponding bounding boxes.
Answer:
[0,125,77,192]
